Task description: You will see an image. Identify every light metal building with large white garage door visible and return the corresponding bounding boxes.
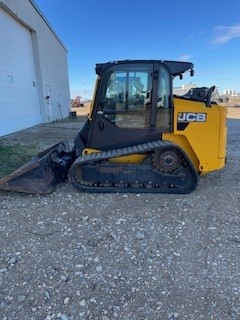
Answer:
[0,0,70,136]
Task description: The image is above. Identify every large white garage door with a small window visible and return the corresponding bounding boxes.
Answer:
[0,8,41,136]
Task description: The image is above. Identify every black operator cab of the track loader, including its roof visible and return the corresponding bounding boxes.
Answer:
[87,60,193,150]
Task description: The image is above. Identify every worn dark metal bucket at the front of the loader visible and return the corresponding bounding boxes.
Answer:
[0,141,75,194]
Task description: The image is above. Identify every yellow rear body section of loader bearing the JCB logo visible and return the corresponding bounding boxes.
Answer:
[163,98,227,174]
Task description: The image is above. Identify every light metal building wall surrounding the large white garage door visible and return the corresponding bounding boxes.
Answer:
[0,0,70,132]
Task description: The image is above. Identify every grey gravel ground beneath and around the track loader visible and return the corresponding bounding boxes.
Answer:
[0,119,240,320]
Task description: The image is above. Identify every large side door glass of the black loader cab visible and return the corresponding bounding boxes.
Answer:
[100,65,152,128]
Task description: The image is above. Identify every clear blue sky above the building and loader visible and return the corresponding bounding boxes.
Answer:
[35,0,240,98]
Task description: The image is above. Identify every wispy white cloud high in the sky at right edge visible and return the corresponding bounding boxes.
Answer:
[213,24,240,45]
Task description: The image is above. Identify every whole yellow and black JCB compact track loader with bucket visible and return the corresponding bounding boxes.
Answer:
[0,60,227,193]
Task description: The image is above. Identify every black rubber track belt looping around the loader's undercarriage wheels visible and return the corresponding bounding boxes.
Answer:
[69,140,198,193]
